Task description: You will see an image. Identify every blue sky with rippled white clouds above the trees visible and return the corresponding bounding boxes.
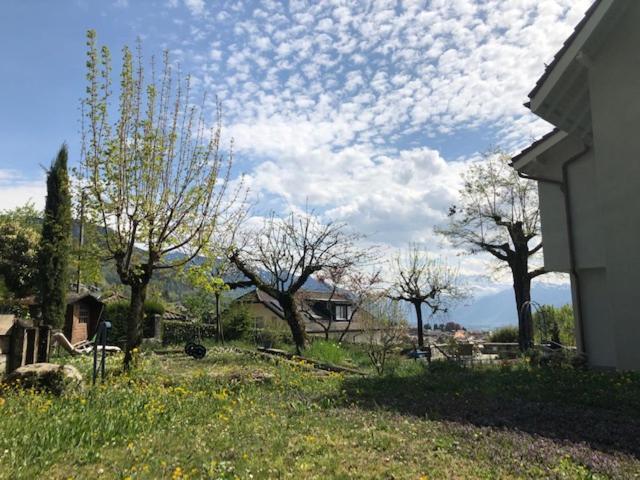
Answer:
[0,0,590,298]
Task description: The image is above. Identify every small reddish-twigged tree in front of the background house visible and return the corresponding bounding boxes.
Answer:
[301,266,383,342]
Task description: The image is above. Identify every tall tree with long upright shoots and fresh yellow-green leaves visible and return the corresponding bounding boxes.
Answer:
[81,31,241,367]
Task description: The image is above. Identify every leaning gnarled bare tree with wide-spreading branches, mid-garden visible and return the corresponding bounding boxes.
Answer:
[230,212,366,352]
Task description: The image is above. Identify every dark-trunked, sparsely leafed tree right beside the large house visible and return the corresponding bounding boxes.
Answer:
[438,153,546,350]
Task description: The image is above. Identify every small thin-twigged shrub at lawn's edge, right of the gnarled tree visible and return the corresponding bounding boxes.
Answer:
[362,299,407,375]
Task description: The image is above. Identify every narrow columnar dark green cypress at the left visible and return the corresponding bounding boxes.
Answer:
[38,145,71,328]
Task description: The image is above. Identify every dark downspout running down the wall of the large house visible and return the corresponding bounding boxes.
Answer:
[518,145,590,355]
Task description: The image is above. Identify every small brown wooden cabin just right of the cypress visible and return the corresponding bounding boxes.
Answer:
[63,292,104,344]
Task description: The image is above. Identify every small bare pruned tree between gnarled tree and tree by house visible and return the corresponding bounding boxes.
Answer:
[390,244,463,348]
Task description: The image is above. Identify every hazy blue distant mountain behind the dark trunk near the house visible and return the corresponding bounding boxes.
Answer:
[414,284,571,330]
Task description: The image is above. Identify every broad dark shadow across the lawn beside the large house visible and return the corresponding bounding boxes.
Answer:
[344,365,640,459]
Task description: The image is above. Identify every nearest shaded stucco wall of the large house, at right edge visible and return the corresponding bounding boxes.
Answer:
[589,2,640,369]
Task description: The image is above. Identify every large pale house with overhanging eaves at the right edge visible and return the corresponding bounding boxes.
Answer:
[512,0,640,370]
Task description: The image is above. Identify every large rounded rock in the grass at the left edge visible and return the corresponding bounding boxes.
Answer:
[4,363,84,395]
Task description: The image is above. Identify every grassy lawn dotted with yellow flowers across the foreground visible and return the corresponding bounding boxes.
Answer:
[0,347,640,479]
